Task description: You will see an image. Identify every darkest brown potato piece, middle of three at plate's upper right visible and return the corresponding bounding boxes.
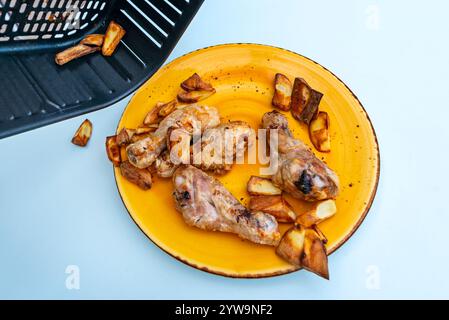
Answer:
[291,78,323,124]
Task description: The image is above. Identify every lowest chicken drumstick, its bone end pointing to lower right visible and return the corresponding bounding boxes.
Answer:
[173,165,280,246]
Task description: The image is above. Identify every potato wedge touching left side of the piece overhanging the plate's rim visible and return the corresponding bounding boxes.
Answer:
[276,226,306,268]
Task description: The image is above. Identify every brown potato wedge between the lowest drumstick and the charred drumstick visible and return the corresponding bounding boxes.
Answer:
[249,196,296,223]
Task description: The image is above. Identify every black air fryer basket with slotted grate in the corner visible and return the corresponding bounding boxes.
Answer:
[0,0,203,138]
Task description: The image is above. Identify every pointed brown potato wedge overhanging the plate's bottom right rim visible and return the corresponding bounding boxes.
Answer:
[301,229,329,280]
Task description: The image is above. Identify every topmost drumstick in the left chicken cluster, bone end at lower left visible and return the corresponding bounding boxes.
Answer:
[126,105,220,168]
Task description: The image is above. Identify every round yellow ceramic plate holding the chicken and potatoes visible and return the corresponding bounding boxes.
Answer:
[115,44,379,277]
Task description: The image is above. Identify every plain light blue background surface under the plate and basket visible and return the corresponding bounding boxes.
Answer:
[0,0,449,299]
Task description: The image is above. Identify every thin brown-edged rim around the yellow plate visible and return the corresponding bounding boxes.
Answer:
[112,42,381,279]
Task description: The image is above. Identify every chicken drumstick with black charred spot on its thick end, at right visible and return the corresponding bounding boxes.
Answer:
[262,111,339,201]
